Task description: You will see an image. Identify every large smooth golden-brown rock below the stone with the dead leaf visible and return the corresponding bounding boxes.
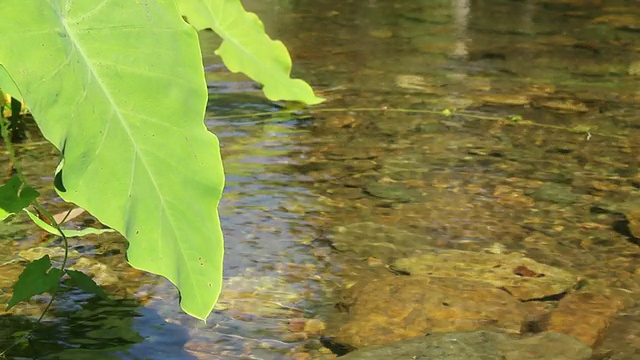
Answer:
[335,276,524,348]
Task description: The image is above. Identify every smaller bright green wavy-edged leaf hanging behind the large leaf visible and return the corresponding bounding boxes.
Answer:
[177,0,324,105]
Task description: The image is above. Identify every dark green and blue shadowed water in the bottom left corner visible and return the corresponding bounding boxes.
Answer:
[0,298,195,360]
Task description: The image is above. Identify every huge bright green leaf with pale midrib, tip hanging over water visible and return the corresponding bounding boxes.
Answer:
[0,0,224,319]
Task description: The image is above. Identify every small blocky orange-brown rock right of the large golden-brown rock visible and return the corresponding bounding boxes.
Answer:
[547,293,624,346]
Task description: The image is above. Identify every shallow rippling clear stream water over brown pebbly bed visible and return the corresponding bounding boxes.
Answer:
[0,0,640,359]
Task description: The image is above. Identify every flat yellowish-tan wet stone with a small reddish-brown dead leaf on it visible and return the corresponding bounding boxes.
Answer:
[393,250,579,300]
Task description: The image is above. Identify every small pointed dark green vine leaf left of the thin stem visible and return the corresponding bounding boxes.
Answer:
[5,255,62,311]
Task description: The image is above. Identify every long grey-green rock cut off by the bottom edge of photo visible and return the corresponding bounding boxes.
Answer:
[340,331,591,360]
